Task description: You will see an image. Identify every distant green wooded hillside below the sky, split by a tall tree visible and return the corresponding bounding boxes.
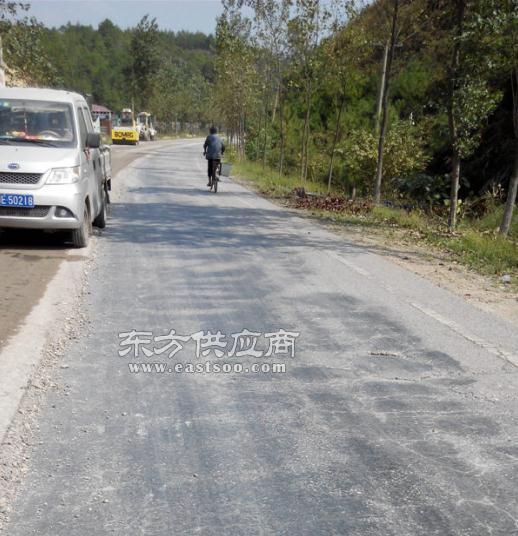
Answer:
[37,20,214,122]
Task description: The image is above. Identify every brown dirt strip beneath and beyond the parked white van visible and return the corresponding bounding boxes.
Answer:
[0,143,152,349]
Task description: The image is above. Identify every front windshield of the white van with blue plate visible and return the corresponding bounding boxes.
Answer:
[0,99,76,147]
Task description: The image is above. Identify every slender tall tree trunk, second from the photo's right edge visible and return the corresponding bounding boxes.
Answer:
[448,0,466,232]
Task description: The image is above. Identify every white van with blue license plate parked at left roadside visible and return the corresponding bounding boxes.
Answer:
[0,88,111,247]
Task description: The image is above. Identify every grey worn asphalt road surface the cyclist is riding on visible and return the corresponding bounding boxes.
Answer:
[7,141,518,536]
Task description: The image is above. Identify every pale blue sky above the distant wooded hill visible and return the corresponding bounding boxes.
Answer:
[29,0,221,33]
